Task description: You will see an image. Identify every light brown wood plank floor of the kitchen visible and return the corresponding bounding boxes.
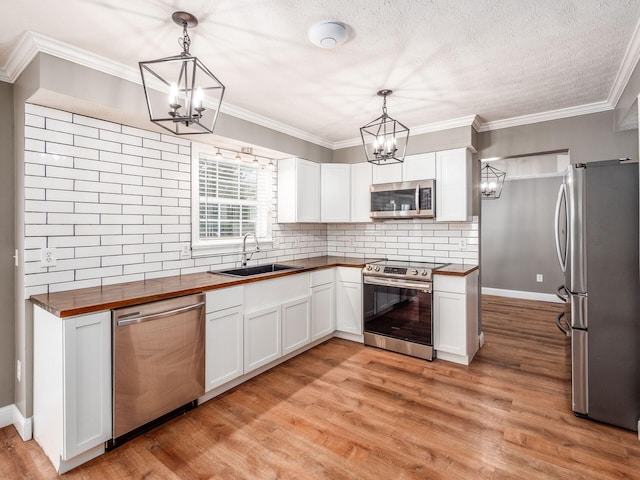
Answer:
[0,297,640,480]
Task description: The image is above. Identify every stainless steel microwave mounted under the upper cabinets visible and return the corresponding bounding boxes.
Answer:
[371,179,436,218]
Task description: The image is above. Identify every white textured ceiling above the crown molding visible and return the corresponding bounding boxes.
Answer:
[0,0,640,143]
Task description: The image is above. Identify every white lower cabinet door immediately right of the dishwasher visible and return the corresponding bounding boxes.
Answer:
[205,307,244,391]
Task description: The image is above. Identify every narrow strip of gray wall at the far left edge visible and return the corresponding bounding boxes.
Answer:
[0,82,15,408]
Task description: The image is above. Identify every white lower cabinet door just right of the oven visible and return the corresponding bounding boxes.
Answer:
[433,292,467,356]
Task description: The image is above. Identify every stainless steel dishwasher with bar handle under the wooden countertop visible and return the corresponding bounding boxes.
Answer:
[107,294,205,448]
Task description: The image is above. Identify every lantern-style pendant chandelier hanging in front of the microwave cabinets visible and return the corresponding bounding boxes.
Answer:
[360,90,409,165]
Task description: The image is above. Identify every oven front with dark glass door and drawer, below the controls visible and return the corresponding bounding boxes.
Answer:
[363,276,433,360]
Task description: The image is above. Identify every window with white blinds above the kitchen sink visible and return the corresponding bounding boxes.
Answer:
[192,144,272,251]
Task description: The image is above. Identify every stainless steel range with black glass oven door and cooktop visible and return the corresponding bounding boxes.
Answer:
[362,260,446,360]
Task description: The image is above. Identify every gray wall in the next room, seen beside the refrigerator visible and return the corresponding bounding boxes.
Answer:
[480,176,563,294]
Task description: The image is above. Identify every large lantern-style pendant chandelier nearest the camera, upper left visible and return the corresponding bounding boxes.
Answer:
[139,12,224,135]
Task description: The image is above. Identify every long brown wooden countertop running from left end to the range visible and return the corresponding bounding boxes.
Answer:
[31,256,373,318]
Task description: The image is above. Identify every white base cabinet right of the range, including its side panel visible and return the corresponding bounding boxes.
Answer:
[433,270,478,365]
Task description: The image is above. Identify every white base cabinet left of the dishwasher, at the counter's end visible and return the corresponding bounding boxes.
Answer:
[33,307,112,473]
